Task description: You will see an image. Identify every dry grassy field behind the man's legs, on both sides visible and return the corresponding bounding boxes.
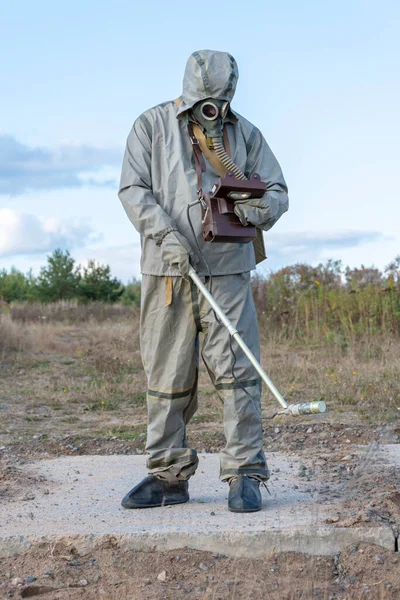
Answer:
[0,313,400,443]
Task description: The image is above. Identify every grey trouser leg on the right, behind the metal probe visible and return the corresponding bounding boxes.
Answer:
[200,273,269,480]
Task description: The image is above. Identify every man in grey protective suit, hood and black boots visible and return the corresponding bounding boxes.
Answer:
[119,50,288,512]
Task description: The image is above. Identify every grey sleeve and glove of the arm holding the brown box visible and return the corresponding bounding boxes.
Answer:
[242,127,289,231]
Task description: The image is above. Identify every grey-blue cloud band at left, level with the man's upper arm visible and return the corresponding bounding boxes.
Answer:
[0,134,122,196]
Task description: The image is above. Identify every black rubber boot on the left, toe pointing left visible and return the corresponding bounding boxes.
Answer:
[121,475,189,508]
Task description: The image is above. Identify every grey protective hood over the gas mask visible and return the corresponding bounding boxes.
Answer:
[177,50,239,121]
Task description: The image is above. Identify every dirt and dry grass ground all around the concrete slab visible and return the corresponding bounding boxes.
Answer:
[0,322,400,600]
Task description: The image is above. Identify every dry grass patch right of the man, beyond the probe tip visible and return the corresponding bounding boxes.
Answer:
[262,335,400,423]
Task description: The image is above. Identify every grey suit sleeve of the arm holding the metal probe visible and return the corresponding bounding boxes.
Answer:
[118,117,176,242]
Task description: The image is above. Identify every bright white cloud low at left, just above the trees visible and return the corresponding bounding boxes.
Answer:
[0,208,99,257]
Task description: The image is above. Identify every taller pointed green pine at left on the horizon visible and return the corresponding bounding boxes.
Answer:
[36,249,80,302]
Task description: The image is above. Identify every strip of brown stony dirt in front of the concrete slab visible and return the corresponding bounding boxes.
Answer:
[0,543,400,600]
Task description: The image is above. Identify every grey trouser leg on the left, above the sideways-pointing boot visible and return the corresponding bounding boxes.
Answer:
[140,275,199,482]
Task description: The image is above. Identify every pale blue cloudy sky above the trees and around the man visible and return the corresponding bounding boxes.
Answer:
[0,0,400,281]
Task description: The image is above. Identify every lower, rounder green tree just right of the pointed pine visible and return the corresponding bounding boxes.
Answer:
[78,260,125,302]
